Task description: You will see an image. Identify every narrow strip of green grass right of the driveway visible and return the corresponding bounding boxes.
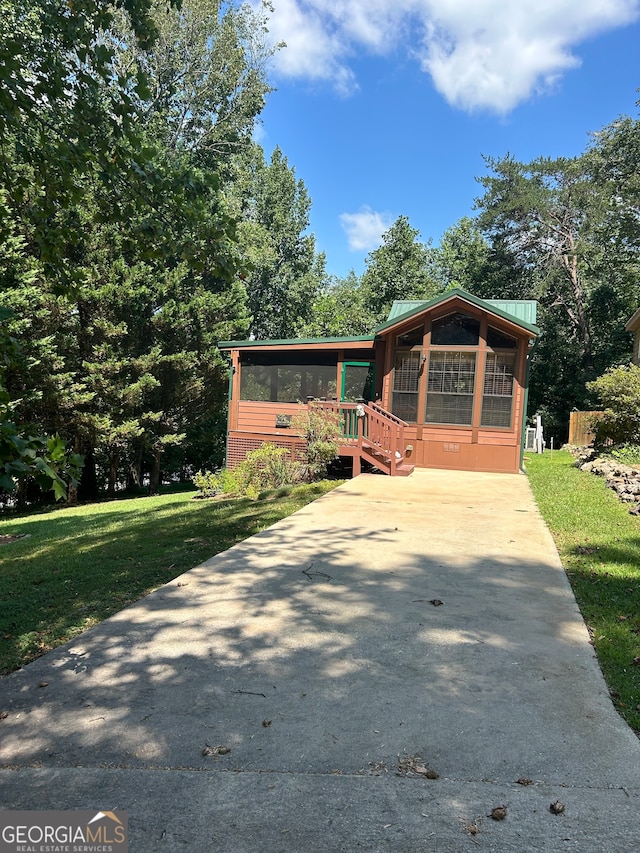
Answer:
[526,451,640,734]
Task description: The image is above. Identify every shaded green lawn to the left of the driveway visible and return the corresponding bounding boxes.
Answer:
[0,481,338,674]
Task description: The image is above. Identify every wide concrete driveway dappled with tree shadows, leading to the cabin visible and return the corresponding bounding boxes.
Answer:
[0,471,640,853]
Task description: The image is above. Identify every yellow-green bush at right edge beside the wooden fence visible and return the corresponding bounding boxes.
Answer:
[587,364,640,447]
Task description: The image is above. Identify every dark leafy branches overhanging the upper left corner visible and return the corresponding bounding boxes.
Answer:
[0,0,182,286]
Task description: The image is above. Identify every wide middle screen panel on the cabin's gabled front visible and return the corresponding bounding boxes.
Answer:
[425,350,476,426]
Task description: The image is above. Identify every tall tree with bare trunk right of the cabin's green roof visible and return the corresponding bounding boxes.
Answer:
[477,136,638,439]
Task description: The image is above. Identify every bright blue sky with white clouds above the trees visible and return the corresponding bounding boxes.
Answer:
[254,0,640,276]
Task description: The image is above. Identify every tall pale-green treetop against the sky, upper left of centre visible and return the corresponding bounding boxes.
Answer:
[113,0,279,163]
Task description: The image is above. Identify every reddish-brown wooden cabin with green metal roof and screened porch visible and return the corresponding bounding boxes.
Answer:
[219,289,539,476]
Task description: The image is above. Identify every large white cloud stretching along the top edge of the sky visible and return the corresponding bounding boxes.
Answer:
[260,0,640,112]
